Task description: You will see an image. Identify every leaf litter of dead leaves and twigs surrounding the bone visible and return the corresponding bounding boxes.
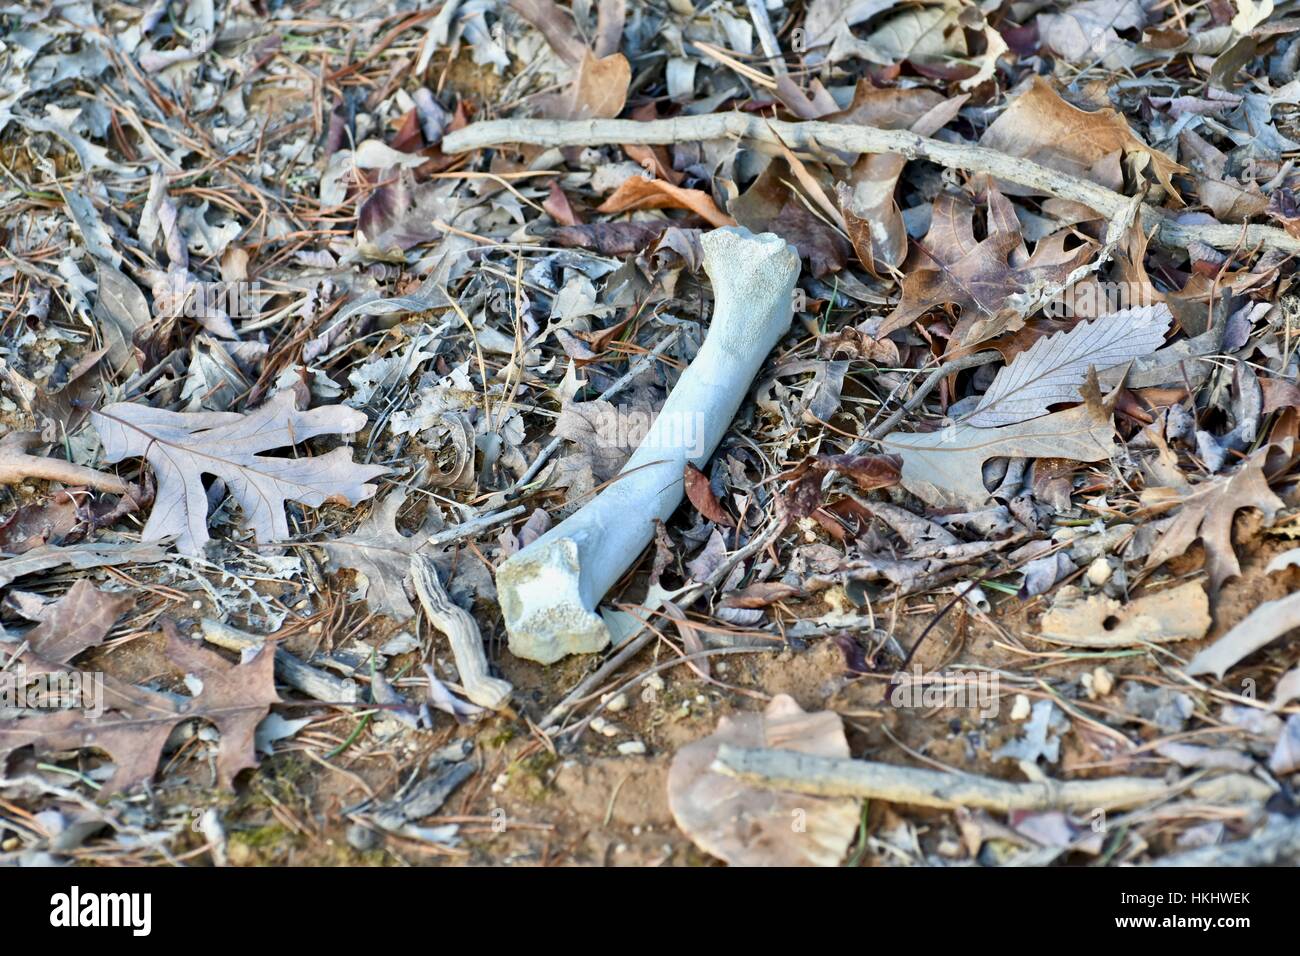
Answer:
[0,0,1300,865]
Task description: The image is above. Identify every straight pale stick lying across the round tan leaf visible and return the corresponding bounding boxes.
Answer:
[710,744,1273,813]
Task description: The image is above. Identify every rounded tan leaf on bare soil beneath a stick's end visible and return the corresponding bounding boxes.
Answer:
[668,693,858,866]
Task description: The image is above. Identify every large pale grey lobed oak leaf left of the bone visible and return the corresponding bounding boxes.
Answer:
[92,390,387,554]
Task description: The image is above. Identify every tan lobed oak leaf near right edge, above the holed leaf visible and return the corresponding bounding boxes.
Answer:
[1147,445,1283,592]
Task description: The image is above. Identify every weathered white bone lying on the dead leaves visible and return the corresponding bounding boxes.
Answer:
[497,228,800,663]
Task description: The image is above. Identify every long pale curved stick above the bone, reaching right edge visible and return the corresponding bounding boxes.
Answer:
[442,113,1300,255]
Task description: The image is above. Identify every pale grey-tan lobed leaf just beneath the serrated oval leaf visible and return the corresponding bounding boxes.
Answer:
[880,371,1115,507]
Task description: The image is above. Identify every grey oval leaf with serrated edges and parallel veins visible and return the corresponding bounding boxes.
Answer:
[965,304,1171,428]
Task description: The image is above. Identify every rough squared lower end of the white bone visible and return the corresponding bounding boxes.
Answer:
[497,537,610,663]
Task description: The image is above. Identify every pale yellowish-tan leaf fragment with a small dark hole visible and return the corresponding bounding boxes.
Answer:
[1040,581,1210,648]
